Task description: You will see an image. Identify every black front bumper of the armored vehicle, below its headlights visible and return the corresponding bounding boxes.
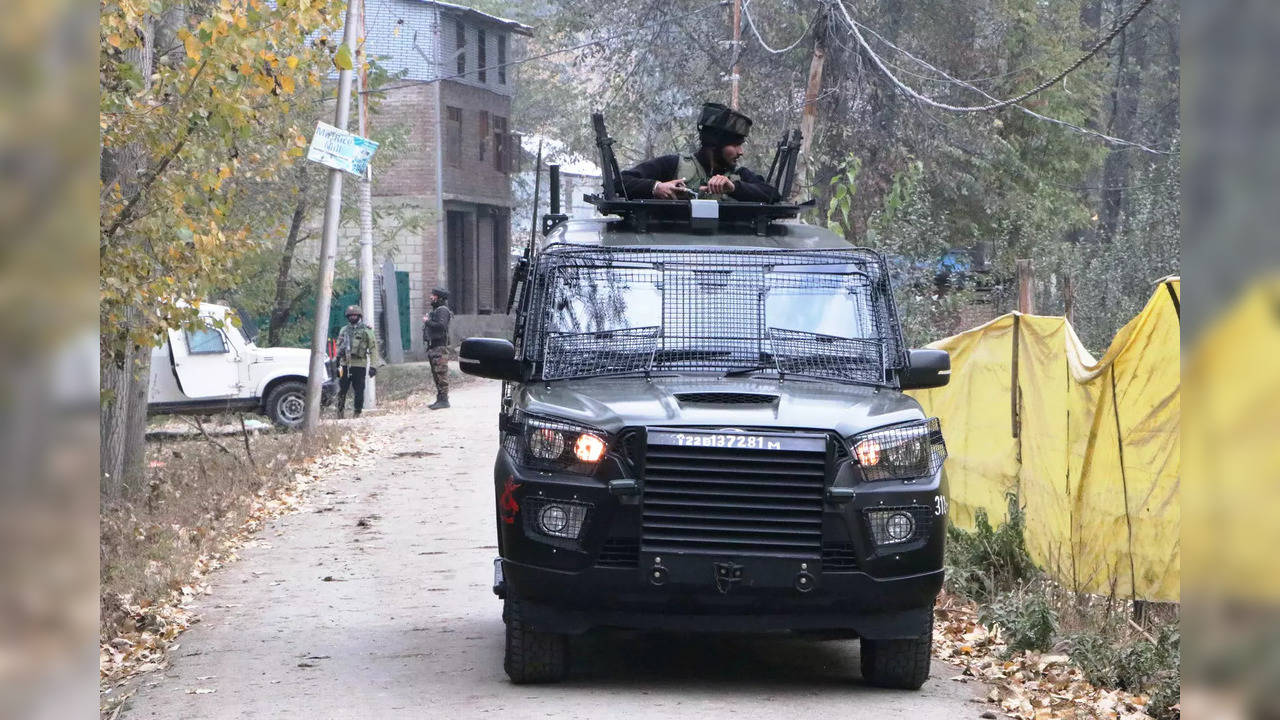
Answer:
[494,443,946,639]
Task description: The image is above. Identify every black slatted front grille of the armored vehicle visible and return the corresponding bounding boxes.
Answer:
[641,430,827,559]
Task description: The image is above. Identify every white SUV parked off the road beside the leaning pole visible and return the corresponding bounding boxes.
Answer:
[147,302,337,428]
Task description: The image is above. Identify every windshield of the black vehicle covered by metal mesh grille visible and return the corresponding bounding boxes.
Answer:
[522,246,904,384]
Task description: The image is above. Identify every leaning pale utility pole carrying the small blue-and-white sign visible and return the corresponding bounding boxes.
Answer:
[302,0,360,433]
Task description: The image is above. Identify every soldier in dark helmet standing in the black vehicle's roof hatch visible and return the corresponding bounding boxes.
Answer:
[621,102,781,202]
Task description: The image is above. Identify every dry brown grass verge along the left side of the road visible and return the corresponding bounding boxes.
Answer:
[99,425,344,641]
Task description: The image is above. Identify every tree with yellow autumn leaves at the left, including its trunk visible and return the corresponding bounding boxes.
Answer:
[99,0,343,488]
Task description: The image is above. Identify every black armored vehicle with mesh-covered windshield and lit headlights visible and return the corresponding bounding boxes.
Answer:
[461,120,950,689]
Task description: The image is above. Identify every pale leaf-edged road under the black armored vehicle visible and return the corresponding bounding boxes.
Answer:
[124,382,987,720]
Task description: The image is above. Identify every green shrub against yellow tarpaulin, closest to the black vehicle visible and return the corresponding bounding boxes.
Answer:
[946,495,1039,603]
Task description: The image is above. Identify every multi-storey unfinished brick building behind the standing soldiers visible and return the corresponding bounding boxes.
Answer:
[365,0,531,357]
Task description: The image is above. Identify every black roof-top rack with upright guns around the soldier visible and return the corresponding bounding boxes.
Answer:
[582,113,814,236]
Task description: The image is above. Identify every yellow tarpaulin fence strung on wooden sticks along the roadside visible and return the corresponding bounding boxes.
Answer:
[911,278,1181,601]
